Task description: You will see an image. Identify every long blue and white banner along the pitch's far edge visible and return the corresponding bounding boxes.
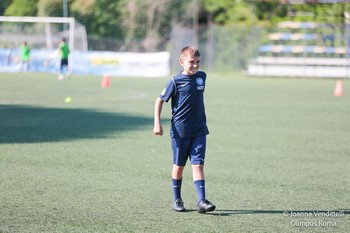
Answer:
[0,49,170,77]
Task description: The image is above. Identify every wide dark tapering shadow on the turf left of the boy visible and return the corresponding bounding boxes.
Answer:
[0,105,153,144]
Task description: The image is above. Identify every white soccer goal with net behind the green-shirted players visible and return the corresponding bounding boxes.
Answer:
[0,16,88,72]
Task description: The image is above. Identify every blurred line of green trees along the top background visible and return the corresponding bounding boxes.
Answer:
[0,0,350,50]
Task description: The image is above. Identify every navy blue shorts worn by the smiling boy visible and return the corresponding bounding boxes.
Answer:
[171,136,206,166]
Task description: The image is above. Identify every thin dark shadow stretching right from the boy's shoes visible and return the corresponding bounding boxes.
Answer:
[206,209,350,218]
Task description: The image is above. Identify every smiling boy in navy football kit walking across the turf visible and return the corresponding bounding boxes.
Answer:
[153,46,215,213]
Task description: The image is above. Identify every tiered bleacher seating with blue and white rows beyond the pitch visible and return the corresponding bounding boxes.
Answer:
[248,21,350,77]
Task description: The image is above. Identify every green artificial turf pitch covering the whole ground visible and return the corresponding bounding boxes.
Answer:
[0,73,350,233]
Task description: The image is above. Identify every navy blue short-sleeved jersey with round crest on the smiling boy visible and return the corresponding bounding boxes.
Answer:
[159,71,209,138]
